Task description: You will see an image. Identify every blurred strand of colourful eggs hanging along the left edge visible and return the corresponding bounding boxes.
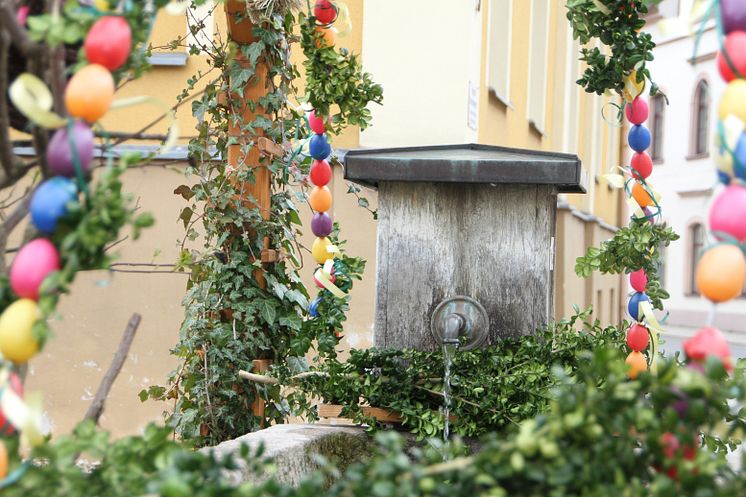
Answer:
[0,6,137,476]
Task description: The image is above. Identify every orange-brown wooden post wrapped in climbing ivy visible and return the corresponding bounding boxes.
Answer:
[225,0,272,288]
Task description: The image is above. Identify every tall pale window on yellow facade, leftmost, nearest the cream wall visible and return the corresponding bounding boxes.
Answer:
[487,0,513,106]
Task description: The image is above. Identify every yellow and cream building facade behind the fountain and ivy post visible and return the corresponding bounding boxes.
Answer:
[16,0,624,434]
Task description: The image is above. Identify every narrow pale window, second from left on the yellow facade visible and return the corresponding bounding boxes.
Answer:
[527,0,549,134]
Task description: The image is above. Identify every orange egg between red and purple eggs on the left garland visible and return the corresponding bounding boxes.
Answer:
[65,64,115,123]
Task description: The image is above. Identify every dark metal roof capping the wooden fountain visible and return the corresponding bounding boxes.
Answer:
[344,144,586,193]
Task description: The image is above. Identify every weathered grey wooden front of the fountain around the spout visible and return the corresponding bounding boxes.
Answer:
[375,182,556,350]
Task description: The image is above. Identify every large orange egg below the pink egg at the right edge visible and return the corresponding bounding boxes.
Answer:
[696,245,746,303]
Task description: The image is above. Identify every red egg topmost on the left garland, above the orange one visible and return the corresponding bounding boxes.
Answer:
[83,16,132,71]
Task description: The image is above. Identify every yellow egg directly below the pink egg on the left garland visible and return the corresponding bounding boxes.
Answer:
[0,299,42,364]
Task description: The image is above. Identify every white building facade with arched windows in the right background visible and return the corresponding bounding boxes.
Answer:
[650,0,746,335]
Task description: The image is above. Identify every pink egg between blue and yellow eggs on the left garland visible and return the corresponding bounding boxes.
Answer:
[10,238,60,300]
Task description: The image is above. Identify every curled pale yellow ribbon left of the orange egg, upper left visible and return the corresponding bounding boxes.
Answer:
[8,73,66,129]
